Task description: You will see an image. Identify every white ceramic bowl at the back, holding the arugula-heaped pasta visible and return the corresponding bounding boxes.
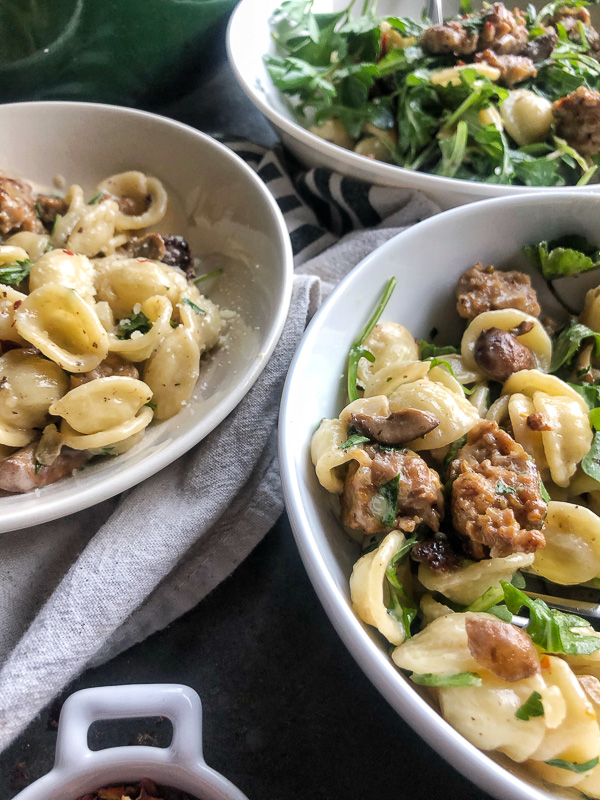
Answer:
[227,0,600,208]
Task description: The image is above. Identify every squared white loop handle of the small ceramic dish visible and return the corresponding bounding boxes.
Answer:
[56,683,203,767]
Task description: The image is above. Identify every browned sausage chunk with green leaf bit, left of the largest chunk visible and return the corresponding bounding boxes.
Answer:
[341,445,444,534]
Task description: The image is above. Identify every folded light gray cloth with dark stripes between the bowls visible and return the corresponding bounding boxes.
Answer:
[0,140,438,749]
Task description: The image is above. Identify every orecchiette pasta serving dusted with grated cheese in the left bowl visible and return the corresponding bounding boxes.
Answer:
[0,172,224,492]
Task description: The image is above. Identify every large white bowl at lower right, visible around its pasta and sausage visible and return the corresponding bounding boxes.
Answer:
[279,192,600,800]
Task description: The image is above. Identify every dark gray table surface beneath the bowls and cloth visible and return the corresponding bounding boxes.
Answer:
[0,31,487,800]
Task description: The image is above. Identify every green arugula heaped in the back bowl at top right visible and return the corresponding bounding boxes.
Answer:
[264,0,600,186]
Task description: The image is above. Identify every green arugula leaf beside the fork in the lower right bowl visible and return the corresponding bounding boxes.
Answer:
[500,581,600,655]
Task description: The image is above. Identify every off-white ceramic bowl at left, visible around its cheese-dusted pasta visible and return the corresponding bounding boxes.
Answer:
[0,102,293,532]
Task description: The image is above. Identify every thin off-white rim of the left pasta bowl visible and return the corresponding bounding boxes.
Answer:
[0,100,294,531]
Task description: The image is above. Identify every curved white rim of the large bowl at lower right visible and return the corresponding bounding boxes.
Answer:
[278,191,600,800]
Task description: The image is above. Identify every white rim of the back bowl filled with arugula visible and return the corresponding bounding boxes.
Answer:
[227,0,600,198]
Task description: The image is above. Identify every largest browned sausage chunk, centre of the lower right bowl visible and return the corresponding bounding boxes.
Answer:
[450,420,547,560]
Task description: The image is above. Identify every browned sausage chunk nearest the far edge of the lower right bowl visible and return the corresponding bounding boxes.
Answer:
[456,262,542,320]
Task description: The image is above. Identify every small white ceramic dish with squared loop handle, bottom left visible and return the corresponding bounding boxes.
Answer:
[14,684,247,800]
